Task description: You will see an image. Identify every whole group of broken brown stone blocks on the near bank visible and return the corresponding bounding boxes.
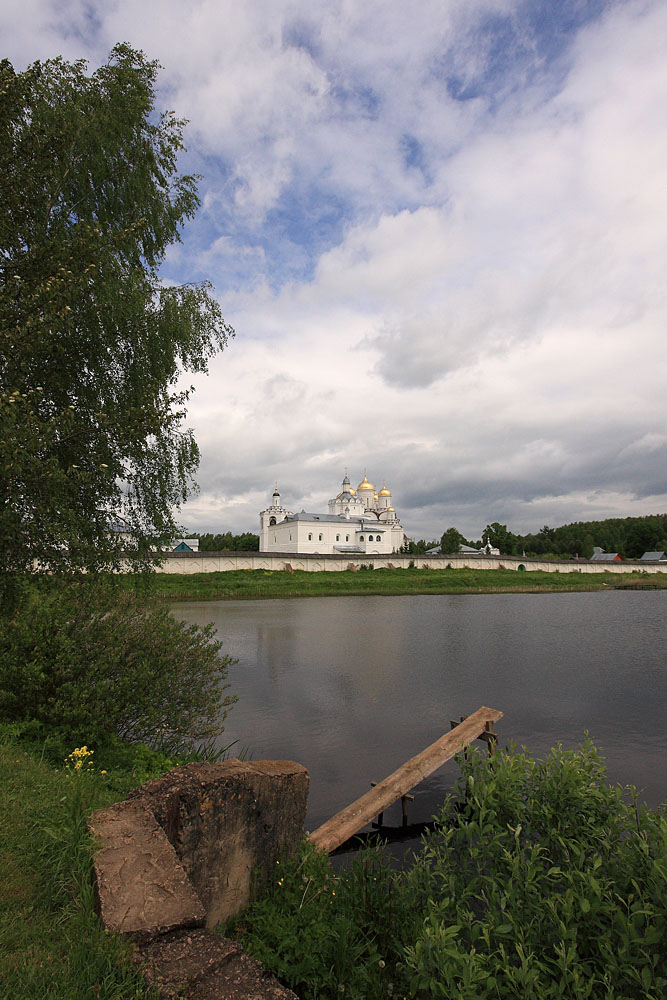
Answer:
[89,760,309,1000]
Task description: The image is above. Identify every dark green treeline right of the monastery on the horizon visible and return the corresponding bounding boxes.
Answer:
[441,514,667,559]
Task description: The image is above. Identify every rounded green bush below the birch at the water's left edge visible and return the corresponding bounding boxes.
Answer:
[0,581,235,747]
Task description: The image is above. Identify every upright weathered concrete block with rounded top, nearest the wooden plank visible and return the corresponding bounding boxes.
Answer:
[129,760,309,928]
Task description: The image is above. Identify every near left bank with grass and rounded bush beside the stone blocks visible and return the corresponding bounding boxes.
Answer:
[0,575,237,1000]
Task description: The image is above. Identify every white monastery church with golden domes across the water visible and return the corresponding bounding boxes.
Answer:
[259,473,404,555]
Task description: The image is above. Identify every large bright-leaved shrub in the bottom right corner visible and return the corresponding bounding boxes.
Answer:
[406,742,667,1000]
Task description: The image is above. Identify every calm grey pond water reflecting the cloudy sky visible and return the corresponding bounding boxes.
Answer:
[173,591,667,830]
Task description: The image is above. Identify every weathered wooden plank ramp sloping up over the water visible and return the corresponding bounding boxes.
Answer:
[308,706,503,854]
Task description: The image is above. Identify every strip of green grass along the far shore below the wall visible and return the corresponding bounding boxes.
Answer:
[137,569,667,601]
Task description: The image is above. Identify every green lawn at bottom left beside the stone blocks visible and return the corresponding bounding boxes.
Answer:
[0,727,176,1000]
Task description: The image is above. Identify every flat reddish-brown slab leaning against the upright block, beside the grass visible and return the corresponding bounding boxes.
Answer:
[89,802,206,938]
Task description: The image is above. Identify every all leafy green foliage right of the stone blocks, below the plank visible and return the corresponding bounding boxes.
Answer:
[235,741,667,1000]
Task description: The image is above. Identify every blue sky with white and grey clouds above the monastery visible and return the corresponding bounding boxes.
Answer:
[5,0,667,538]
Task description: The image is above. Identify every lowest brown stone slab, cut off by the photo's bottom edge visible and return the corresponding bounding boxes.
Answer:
[135,930,297,1000]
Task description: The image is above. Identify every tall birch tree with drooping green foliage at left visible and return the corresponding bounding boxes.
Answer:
[0,45,232,610]
